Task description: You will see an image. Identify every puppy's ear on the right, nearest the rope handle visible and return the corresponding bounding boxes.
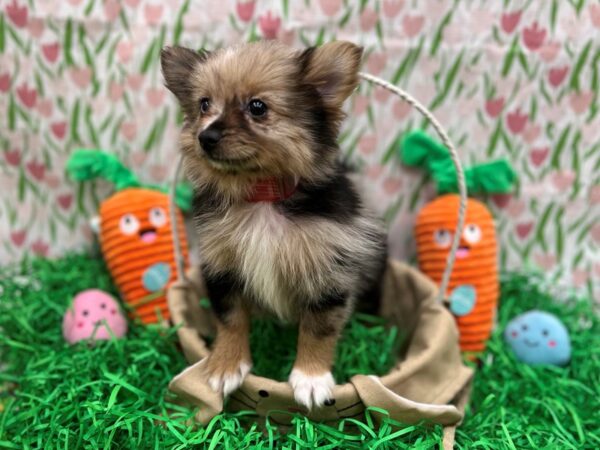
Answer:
[300,41,363,107]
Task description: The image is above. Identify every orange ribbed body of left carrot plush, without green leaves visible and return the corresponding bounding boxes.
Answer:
[100,188,187,323]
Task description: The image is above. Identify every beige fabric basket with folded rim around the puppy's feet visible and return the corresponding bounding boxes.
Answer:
[168,261,473,434]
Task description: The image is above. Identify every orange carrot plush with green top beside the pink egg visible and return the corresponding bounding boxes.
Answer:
[67,150,191,324]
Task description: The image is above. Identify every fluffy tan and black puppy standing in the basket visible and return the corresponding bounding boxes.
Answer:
[161,42,386,409]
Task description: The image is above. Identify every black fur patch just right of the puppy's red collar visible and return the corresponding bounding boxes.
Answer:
[281,163,361,223]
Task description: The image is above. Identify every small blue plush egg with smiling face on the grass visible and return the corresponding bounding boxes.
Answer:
[504,310,571,366]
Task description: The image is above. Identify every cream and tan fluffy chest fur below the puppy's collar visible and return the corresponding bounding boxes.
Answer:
[198,189,380,320]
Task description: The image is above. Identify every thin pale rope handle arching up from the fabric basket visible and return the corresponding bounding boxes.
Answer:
[169,72,467,302]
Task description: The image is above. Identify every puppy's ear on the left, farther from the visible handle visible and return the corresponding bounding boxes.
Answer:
[160,46,208,106]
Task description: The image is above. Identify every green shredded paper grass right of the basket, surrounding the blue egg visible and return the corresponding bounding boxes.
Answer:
[457,274,600,449]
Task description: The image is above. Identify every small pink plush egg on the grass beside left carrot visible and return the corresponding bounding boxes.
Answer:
[63,289,127,344]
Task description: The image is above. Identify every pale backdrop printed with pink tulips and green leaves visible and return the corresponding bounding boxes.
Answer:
[0,0,600,300]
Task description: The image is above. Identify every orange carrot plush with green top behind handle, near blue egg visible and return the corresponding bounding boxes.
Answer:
[401,131,515,352]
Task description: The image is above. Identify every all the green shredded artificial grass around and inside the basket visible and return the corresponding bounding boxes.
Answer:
[0,251,600,449]
